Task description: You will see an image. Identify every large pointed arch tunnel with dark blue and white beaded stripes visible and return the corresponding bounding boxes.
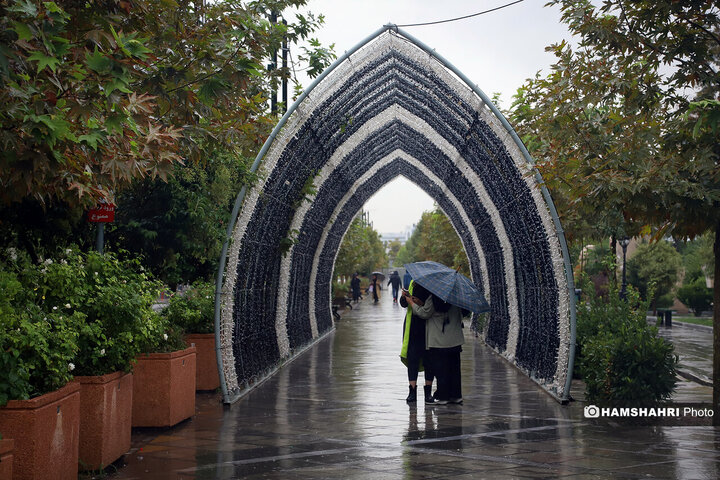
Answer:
[216,26,575,402]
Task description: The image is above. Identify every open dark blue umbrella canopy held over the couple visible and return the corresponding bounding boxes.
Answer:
[405,261,490,313]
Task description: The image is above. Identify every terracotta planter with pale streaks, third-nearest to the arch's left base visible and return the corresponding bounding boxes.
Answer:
[75,372,133,470]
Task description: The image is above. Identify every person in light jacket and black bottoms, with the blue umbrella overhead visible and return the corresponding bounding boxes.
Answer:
[405,262,490,405]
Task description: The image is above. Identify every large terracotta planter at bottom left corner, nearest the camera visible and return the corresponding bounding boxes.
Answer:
[0,382,80,480]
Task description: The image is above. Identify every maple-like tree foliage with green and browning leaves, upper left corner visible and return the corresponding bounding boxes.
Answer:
[0,0,334,206]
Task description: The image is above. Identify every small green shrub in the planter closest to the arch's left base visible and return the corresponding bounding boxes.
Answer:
[162,281,215,333]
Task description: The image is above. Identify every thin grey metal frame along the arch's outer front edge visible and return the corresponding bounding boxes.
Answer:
[215,24,576,403]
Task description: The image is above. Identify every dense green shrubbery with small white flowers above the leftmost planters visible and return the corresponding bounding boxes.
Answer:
[0,248,172,404]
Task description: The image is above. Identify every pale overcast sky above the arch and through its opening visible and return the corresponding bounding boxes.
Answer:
[294,0,569,234]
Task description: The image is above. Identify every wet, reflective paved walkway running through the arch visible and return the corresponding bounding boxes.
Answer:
[112,296,720,480]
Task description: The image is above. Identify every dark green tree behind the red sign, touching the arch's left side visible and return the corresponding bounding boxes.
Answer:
[106,149,251,286]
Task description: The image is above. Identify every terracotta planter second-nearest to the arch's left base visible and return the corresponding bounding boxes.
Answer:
[132,347,195,427]
